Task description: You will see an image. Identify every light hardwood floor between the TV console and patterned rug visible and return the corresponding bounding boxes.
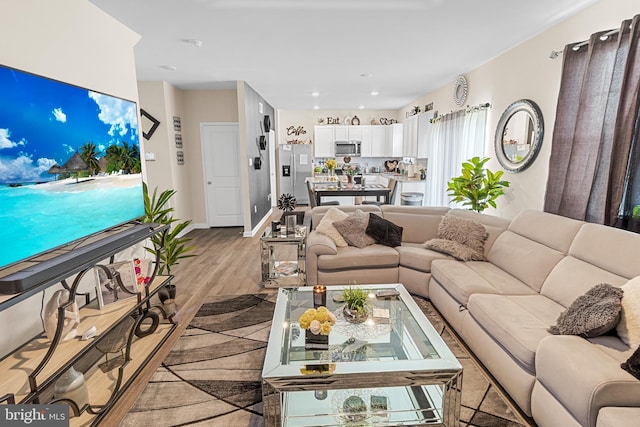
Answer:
[108,212,292,426]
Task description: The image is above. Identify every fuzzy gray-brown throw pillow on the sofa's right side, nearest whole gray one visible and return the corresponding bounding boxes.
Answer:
[548,283,622,338]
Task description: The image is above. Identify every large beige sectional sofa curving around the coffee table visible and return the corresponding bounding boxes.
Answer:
[307,206,640,426]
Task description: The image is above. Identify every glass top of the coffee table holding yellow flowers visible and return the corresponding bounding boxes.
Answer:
[263,284,461,377]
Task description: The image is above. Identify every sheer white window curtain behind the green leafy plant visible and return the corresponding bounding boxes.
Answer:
[425,108,487,206]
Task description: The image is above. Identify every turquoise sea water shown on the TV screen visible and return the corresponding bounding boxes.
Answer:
[0,179,144,267]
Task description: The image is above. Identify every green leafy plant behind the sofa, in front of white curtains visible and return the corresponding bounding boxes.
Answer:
[447,156,509,212]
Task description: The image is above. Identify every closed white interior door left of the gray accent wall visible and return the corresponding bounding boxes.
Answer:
[201,124,243,227]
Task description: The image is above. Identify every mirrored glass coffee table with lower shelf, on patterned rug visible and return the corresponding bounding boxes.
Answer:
[262,284,462,426]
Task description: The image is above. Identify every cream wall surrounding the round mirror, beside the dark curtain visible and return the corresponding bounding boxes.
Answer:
[400,0,640,221]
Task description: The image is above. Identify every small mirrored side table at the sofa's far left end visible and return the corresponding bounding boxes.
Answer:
[260,225,307,288]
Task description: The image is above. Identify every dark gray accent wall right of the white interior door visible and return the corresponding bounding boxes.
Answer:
[243,83,275,229]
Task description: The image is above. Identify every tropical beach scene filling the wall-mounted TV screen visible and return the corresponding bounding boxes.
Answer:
[0,66,144,268]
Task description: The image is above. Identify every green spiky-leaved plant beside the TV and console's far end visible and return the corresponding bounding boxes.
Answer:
[142,182,196,274]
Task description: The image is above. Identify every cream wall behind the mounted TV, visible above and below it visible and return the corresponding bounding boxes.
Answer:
[0,0,139,357]
